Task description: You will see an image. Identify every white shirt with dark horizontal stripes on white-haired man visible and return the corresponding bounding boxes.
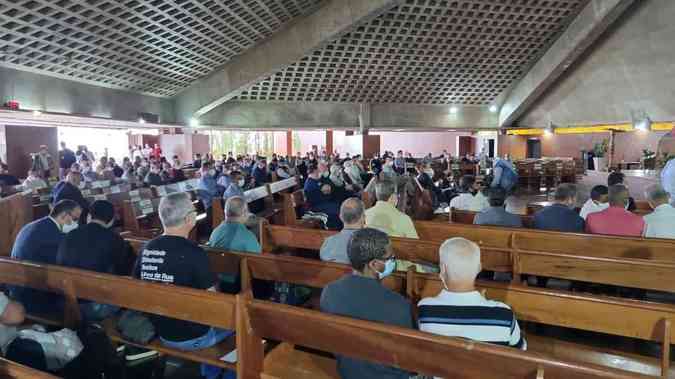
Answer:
[417,290,527,350]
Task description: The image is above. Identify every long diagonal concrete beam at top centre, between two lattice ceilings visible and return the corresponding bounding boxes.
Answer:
[175,0,403,122]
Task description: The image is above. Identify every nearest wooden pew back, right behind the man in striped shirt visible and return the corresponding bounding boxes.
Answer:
[244,300,650,379]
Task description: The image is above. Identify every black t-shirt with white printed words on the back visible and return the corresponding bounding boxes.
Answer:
[134,236,216,342]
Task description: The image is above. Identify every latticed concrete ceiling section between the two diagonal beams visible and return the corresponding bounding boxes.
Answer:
[238,0,588,105]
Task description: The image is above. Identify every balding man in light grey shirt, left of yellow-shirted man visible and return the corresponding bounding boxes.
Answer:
[319,197,365,264]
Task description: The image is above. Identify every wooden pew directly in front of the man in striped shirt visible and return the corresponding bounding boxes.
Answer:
[407,271,675,378]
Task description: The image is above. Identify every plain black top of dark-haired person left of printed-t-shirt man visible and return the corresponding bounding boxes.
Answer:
[56,223,130,275]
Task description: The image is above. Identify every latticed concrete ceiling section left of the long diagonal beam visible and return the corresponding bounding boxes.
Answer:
[0,0,322,97]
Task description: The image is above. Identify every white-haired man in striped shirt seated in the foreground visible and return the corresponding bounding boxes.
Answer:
[417,238,527,356]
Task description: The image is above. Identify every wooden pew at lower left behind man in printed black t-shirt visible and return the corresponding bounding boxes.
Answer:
[0,259,240,369]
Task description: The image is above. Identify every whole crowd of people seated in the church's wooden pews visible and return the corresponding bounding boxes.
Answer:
[6,145,675,378]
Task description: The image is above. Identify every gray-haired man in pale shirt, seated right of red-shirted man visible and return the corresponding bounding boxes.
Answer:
[644,185,675,239]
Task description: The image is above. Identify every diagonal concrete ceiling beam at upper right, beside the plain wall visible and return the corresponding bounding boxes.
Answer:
[499,0,635,127]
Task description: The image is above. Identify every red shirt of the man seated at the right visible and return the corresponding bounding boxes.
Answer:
[586,207,645,237]
